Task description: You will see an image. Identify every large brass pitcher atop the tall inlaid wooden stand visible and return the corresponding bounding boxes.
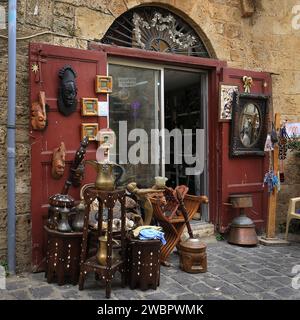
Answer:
[86,160,125,191]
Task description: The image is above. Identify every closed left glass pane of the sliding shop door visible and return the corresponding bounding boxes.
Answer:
[109,63,164,187]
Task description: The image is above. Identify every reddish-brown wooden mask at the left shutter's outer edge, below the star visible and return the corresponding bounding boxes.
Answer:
[31,91,47,131]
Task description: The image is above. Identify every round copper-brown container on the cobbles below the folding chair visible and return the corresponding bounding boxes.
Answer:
[178,238,207,273]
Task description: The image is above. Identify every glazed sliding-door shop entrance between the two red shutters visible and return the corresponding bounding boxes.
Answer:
[108,63,208,221]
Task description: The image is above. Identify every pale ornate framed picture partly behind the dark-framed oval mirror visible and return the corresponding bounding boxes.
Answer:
[219,83,239,121]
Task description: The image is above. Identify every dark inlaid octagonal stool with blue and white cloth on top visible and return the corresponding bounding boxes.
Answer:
[127,239,161,290]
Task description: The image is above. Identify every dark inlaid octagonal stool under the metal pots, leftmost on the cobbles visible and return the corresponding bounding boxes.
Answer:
[44,226,82,286]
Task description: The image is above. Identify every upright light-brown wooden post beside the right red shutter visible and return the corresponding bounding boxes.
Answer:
[266,113,280,239]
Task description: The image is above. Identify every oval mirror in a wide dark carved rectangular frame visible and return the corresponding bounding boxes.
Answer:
[230,92,269,157]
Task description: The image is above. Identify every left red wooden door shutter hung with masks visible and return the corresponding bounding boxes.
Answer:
[29,43,107,271]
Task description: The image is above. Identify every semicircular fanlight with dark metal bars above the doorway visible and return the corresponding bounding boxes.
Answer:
[101,6,210,58]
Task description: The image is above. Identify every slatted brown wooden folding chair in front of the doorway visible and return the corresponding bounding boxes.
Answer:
[150,186,208,266]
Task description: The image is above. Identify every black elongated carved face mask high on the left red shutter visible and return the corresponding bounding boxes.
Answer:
[57,65,77,116]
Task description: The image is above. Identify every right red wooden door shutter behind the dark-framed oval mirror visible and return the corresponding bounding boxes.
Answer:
[218,68,272,232]
